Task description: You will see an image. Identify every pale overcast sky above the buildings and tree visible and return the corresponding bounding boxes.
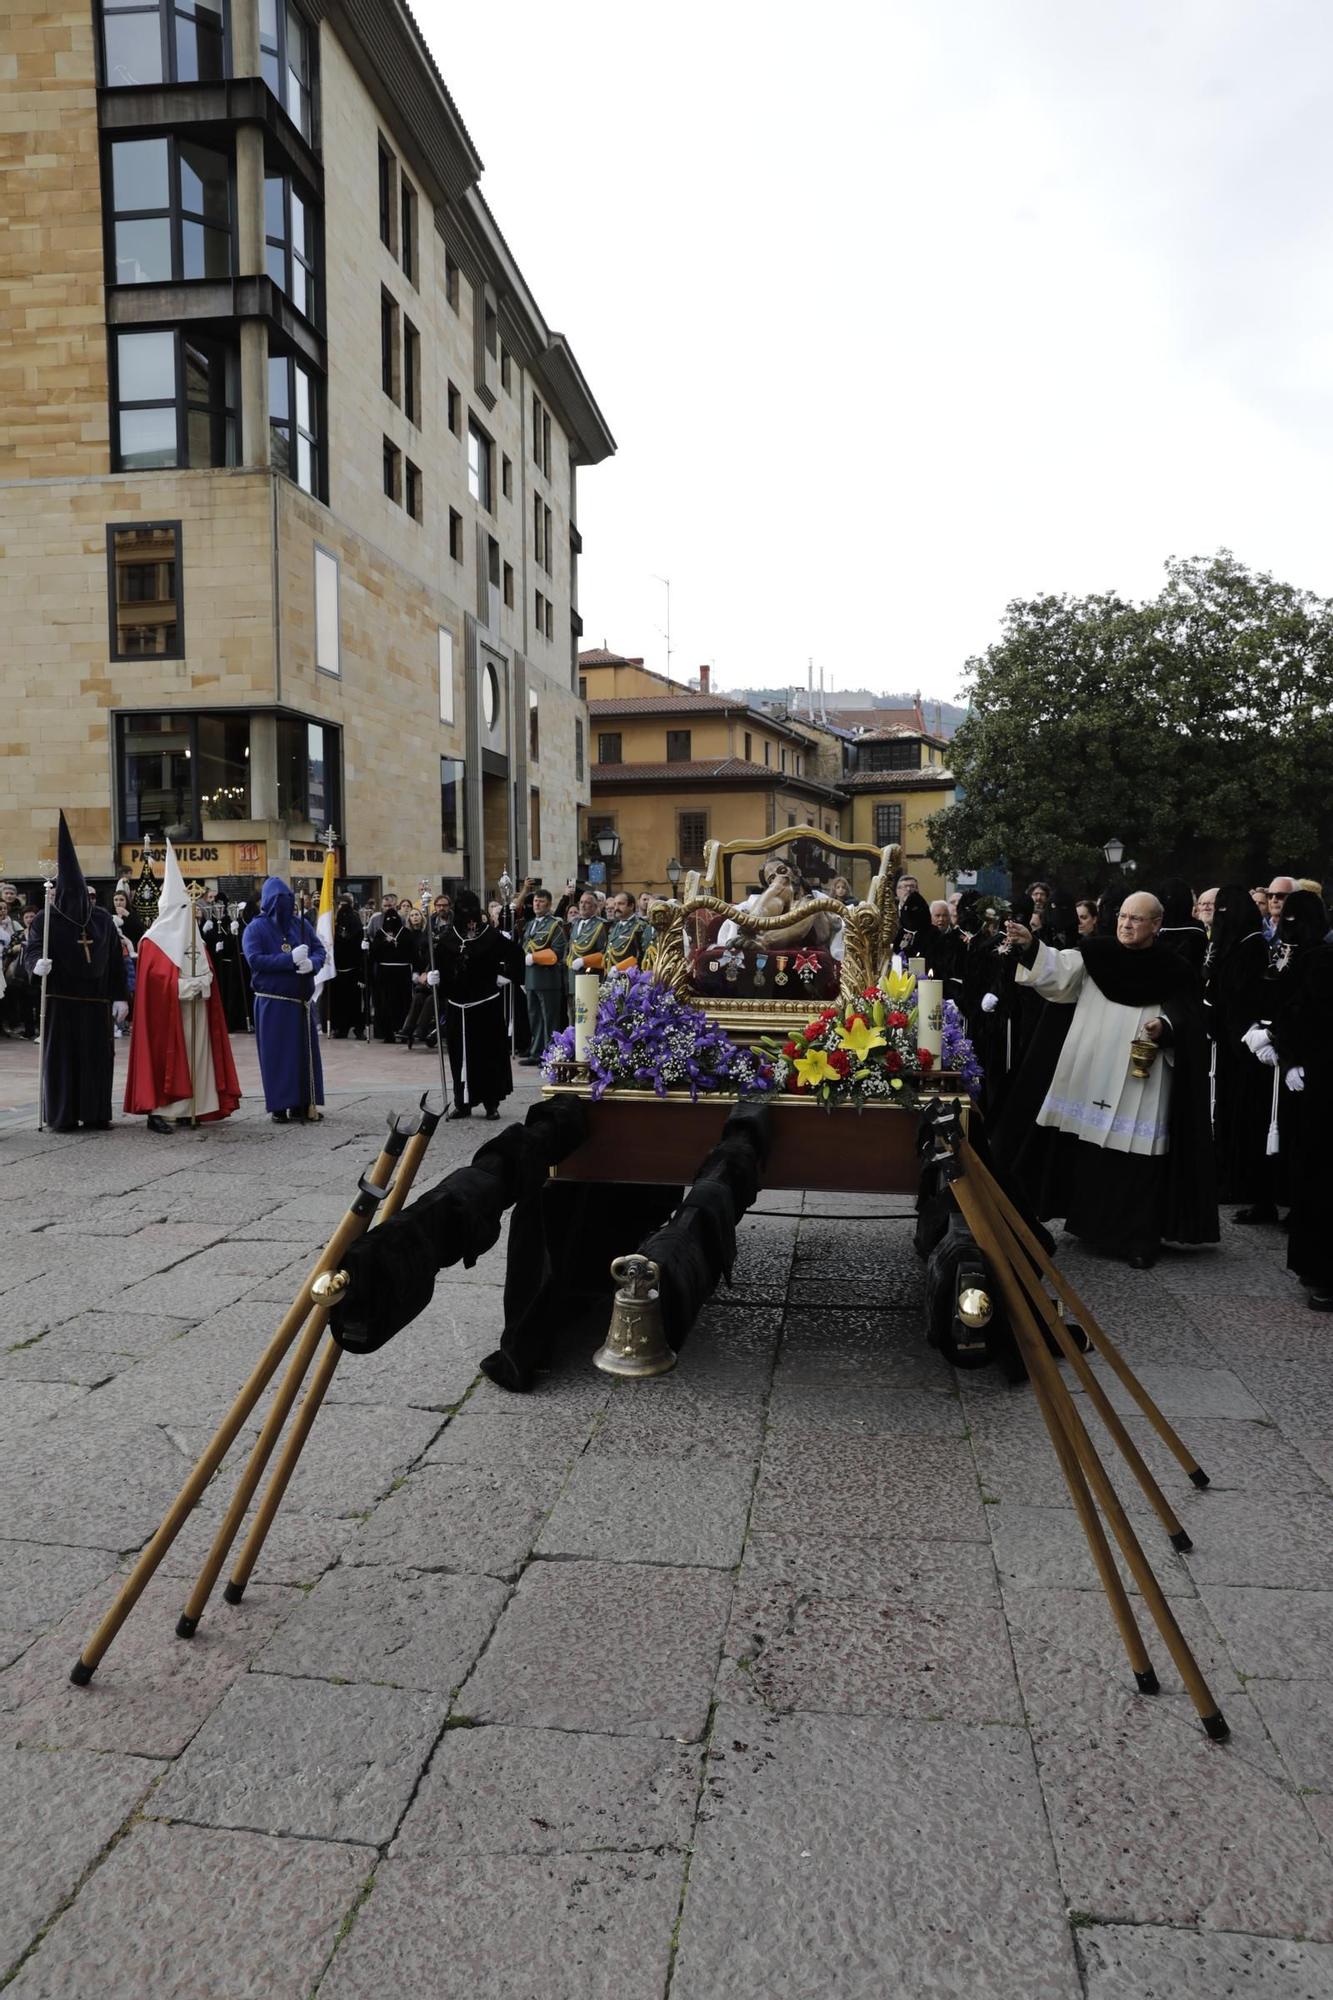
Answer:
[416,0,1333,696]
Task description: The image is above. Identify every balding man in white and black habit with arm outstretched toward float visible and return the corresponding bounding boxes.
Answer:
[1001,894,1219,1270]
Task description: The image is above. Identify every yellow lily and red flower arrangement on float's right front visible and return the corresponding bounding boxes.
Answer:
[759,966,981,1108]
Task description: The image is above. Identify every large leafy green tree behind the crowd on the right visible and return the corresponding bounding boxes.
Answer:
[931,550,1333,888]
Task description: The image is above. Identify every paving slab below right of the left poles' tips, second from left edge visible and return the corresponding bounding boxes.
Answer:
[152,1674,448,1844]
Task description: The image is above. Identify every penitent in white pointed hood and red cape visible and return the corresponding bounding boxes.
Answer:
[124,840,240,1122]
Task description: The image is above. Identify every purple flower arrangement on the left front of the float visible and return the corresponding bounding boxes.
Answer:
[542,972,779,1100]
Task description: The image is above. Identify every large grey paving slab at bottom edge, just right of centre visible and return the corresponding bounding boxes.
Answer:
[671,1708,1079,2000]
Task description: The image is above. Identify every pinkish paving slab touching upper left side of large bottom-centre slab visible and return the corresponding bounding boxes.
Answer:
[390,1728,703,1860]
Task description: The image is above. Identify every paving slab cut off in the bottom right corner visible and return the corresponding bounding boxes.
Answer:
[1079,1924,1333,2000]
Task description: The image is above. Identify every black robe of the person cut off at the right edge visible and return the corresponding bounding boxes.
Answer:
[1273,944,1333,1296]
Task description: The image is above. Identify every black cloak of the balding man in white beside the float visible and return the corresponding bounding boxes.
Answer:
[997,938,1221,1254]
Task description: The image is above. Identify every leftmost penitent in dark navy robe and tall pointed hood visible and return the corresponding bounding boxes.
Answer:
[24,814,128,1132]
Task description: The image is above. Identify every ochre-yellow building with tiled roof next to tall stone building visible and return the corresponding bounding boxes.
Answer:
[578,650,843,894]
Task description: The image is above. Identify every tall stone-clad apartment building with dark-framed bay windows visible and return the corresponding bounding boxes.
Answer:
[0,0,614,892]
